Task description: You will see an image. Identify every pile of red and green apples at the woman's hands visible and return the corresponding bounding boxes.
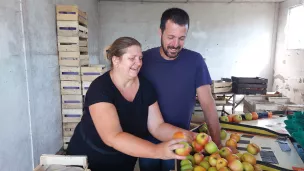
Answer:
[174,132,262,171]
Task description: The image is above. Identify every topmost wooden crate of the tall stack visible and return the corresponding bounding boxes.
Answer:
[56,5,88,25]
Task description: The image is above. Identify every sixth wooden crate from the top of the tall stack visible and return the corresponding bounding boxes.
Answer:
[61,81,81,95]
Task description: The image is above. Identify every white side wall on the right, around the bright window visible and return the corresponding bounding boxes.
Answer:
[273,0,304,104]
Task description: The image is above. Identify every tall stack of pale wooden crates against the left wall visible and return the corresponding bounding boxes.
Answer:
[56,5,89,148]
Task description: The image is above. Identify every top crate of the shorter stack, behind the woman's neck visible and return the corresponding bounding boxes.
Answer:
[80,65,105,81]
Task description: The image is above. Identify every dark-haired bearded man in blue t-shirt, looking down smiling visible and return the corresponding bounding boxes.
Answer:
[139,8,221,171]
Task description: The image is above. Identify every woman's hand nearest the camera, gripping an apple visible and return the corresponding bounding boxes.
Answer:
[156,139,187,160]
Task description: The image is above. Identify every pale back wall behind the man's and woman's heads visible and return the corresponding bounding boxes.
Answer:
[99,2,278,88]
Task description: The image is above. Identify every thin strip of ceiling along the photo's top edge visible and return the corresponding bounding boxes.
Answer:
[99,0,285,3]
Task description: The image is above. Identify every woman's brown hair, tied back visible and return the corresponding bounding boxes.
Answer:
[106,37,141,67]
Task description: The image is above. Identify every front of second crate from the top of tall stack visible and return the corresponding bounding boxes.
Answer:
[57,21,79,37]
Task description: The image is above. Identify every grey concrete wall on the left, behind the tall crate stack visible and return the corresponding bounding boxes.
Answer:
[0,0,100,171]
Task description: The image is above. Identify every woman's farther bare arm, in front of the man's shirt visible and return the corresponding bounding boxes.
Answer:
[148,102,195,141]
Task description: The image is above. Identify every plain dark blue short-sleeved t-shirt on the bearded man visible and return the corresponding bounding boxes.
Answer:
[140,47,212,129]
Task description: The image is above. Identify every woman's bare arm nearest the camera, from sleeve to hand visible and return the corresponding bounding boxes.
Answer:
[89,102,184,159]
